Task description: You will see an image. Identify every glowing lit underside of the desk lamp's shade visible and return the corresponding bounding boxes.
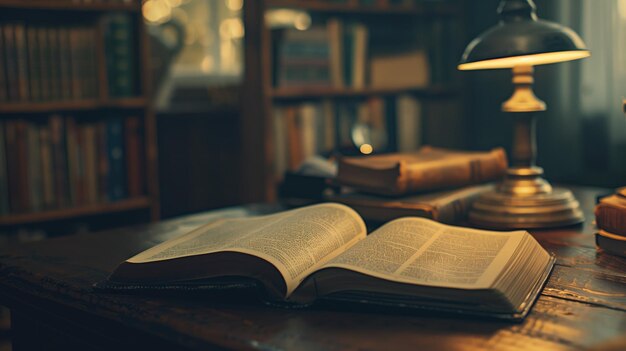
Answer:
[457,50,591,71]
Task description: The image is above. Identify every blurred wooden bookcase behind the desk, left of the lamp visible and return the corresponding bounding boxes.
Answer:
[241,0,468,201]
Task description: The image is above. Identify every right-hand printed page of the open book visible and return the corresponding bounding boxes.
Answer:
[323,218,525,289]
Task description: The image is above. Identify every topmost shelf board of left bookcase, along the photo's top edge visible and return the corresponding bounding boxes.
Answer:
[0,0,139,12]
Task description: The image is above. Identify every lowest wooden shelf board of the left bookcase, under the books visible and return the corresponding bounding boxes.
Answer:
[0,197,150,226]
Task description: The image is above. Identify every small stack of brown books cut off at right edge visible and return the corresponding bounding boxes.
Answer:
[595,188,626,257]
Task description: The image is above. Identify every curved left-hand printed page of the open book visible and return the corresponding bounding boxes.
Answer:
[127,204,366,294]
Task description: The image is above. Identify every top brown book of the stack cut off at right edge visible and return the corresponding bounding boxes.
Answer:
[595,188,626,237]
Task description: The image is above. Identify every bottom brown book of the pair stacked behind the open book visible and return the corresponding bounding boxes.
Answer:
[326,184,494,224]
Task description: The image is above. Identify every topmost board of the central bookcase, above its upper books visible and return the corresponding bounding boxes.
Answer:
[267,0,461,16]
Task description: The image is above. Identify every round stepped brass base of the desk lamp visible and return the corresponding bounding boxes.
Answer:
[469,167,585,229]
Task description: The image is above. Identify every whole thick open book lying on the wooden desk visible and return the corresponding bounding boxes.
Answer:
[101,203,554,319]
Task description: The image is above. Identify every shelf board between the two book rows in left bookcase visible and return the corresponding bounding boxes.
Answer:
[0,97,146,114]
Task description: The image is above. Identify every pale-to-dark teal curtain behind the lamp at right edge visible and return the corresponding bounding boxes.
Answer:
[537,0,626,187]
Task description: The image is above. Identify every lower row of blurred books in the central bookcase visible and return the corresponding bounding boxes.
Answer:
[273,94,421,179]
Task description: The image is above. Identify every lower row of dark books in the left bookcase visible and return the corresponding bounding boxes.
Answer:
[0,115,145,215]
